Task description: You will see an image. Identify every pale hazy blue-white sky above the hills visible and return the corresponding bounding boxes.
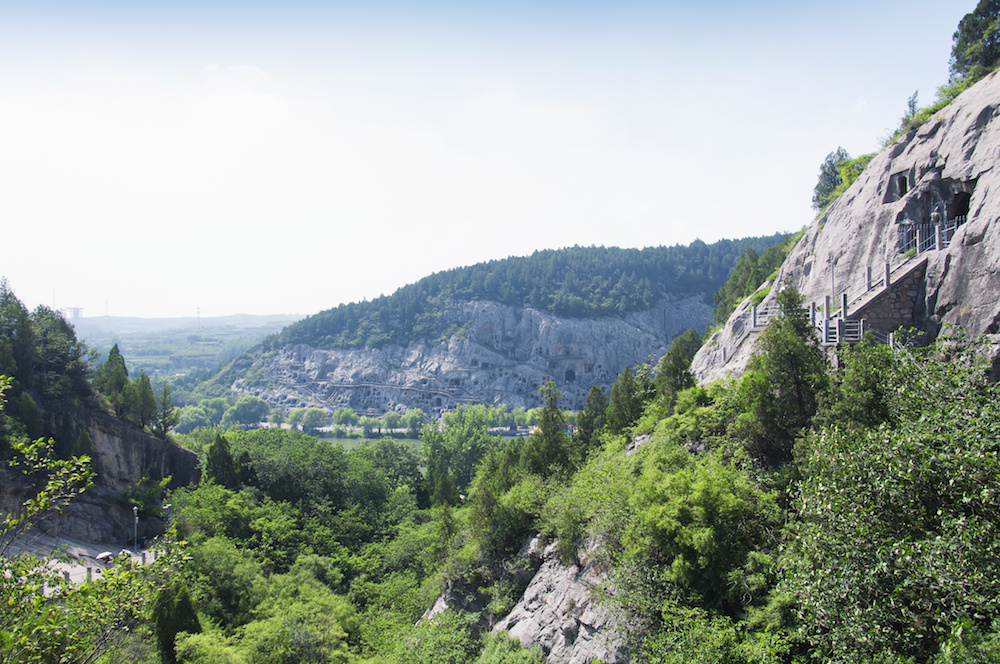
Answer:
[0,0,975,318]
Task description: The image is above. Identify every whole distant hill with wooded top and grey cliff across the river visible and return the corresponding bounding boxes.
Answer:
[224,241,783,414]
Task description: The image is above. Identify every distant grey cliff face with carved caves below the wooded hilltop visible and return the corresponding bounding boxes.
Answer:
[242,297,712,415]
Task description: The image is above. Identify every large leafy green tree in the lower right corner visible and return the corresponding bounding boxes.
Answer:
[779,338,1000,662]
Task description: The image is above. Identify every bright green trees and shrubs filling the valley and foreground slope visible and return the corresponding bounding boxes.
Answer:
[7,304,1000,664]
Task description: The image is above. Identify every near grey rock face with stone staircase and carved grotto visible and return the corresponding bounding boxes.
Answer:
[693,74,1000,381]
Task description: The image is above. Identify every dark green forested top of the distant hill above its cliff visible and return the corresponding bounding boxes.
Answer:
[264,239,784,349]
